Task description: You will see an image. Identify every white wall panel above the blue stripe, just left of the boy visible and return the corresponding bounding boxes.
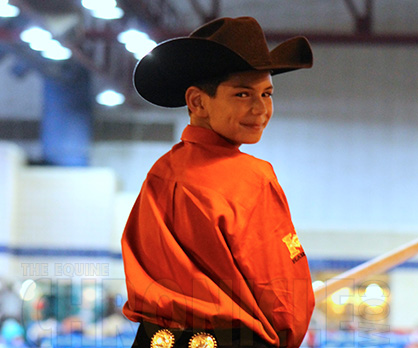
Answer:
[12,167,116,249]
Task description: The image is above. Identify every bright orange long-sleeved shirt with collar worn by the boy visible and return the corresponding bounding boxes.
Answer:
[122,126,314,347]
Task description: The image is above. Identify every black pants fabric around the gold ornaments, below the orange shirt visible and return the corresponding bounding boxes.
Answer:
[132,323,285,348]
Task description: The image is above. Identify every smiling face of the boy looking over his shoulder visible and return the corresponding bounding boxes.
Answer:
[203,71,273,146]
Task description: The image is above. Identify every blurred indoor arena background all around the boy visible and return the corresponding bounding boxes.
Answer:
[0,0,418,347]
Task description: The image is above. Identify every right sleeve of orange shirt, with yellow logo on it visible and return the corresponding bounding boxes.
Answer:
[225,181,314,347]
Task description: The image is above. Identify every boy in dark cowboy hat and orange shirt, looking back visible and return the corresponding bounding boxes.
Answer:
[122,17,314,348]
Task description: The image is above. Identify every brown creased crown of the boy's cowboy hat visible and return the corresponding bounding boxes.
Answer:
[190,17,271,67]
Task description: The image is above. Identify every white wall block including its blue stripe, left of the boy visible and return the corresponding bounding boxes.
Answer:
[7,166,116,278]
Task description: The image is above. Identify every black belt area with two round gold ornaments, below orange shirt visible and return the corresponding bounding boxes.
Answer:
[132,322,286,348]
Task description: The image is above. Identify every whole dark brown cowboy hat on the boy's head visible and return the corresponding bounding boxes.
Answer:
[133,17,312,107]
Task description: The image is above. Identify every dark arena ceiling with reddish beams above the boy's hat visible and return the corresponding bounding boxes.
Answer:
[0,0,418,104]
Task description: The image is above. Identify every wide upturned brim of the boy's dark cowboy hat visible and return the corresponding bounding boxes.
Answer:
[133,37,312,107]
